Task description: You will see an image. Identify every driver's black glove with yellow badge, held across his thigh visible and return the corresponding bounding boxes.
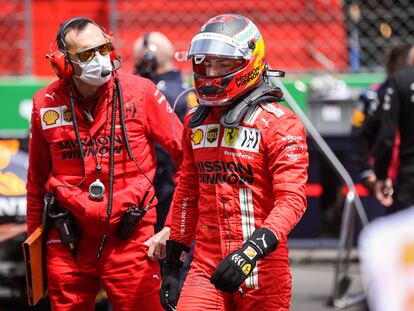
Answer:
[210,227,278,293]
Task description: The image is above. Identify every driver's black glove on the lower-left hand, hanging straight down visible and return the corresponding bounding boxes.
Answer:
[160,240,190,311]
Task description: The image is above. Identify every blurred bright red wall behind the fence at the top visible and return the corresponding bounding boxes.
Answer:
[0,0,348,76]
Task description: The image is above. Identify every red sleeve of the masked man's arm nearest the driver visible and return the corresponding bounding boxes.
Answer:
[144,83,183,226]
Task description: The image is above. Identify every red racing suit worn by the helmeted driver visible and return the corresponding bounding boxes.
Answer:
[170,103,308,311]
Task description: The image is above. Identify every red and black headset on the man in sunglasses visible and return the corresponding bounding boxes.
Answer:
[46,17,121,79]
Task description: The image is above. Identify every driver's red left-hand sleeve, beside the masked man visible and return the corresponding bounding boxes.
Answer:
[170,116,199,246]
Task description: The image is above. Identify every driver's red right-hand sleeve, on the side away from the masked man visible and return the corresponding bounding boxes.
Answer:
[264,114,309,239]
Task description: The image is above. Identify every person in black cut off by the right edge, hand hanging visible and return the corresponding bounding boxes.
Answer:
[374,50,414,212]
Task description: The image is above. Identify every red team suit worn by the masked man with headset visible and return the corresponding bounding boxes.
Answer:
[27,73,182,310]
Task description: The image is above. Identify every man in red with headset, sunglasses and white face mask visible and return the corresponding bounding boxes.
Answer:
[27,17,182,311]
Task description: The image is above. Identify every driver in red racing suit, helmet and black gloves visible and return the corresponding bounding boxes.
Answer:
[160,14,308,311]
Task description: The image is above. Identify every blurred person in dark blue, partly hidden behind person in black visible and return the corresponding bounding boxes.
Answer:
[351,44,414,201]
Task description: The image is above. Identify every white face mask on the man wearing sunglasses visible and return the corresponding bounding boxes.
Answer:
[75,52,112,86]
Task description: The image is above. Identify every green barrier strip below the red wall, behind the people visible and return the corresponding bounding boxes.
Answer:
[0,74,384,138]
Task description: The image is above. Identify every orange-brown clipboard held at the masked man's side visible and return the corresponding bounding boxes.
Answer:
[22,226,47,306]
